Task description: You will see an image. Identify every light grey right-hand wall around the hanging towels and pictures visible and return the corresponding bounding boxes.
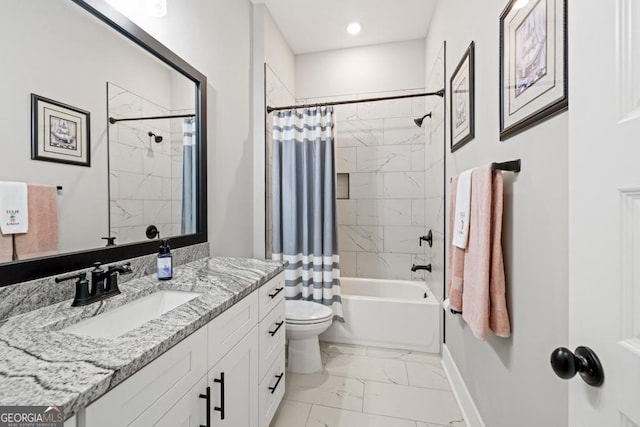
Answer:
[427,0,568,427]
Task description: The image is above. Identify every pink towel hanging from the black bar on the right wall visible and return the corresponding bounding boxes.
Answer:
[447,165,511,340]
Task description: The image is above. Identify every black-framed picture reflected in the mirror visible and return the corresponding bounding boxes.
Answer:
[31,93,91,167]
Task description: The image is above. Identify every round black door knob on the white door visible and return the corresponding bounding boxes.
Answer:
[551,347,604,387]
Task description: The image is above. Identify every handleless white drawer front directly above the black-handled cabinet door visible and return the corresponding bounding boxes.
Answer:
[207,291,258,368]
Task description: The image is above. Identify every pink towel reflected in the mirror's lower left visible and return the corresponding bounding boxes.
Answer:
[0,184,59,263]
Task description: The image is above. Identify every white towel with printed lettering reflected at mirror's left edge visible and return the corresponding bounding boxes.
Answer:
[0,181,29,234]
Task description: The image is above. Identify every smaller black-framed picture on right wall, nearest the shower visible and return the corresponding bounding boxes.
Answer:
[449,41,475,153]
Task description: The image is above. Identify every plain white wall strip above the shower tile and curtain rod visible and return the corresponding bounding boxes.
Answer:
[295,40,425,99]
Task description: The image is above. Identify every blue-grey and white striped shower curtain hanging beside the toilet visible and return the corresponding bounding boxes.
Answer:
[273,107,344,322]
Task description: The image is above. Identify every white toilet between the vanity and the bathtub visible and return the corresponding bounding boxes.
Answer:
[285,300,333,374]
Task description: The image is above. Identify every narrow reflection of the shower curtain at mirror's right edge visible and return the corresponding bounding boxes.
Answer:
[181,117,196,234]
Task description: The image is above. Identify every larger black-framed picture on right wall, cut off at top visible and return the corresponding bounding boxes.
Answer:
[500,0,569,141]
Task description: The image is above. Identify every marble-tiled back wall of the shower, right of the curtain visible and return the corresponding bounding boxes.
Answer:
[328,89,428,279]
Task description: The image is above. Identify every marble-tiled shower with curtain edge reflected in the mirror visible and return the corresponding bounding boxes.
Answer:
[107,81,198,244]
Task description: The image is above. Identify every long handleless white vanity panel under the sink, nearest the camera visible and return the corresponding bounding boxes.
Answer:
[85,329,207,427]
